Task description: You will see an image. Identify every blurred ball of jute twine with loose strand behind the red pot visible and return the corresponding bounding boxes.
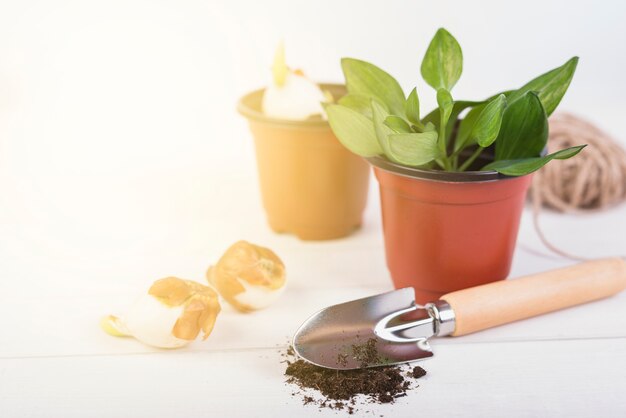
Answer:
[530,113,626,260]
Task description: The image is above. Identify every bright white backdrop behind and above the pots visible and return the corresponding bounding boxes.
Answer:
[0,0,626,285]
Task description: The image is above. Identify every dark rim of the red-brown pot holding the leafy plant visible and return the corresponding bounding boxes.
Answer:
[367,157,516,183]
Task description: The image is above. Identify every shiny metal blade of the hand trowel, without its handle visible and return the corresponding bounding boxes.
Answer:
[293,288,433,370]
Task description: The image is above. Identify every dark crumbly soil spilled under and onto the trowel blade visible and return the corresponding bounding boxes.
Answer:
[284,339,426,414]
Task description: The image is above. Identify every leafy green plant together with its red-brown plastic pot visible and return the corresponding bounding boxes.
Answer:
[325,29,585,302]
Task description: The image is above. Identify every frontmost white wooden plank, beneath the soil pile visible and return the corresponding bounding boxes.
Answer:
[0,339,626,418]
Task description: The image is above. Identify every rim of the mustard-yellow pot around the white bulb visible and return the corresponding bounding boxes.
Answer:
[237,83,346,128]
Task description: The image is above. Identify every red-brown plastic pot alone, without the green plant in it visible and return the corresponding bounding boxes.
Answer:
[369,157,532,303]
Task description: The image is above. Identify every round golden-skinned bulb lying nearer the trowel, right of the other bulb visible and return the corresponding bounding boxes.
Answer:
[207,241,286,312]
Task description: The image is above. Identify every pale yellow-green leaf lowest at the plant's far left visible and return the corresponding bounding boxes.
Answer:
[326,105,383,157]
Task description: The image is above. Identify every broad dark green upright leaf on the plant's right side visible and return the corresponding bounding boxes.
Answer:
[495,92,548,161]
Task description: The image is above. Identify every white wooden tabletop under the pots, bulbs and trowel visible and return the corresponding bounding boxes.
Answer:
[0,159,626,418]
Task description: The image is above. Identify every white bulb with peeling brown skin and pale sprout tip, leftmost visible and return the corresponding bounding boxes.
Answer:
[101,277,221,348]
